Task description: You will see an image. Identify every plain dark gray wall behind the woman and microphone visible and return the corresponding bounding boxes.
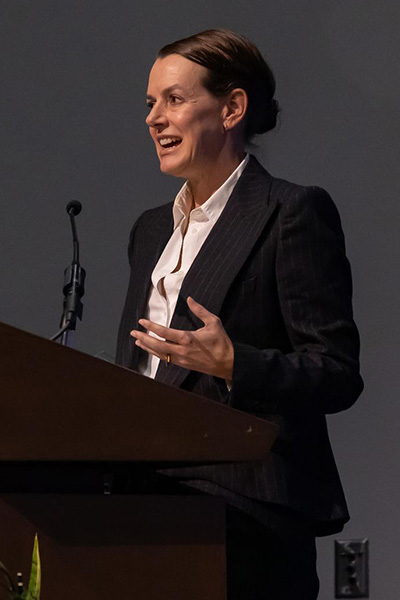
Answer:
[0,0,400,600]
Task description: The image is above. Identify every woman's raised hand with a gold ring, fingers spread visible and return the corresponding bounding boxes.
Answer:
[131,296,234,380]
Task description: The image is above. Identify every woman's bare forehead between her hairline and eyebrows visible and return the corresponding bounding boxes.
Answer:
[147,54,207,95]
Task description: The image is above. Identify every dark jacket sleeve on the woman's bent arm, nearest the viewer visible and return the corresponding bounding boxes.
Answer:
[230,187,363,415]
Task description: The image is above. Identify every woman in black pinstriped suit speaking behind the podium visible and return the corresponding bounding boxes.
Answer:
[117,30,362,600]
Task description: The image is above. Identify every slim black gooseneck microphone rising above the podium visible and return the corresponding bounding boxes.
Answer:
[50,200,86,346]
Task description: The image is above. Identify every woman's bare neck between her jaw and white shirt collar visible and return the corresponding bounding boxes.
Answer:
[188,150,245,208]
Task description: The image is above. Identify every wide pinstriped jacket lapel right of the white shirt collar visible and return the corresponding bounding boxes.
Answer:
[156,157,277,387]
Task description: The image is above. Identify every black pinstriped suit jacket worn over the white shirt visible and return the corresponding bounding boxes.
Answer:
[117,157,363,532]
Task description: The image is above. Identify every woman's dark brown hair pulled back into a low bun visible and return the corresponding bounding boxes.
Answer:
[158,29,279,141]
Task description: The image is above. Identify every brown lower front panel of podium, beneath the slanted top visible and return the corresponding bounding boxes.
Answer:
[0,494,226,600]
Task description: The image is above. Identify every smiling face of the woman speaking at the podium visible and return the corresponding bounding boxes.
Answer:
[146,54,225,181]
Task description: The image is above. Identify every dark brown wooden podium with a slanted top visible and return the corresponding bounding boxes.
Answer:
[0,324,277,600]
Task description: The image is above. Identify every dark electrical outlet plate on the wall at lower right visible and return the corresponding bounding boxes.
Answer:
[335,538,369,598]
